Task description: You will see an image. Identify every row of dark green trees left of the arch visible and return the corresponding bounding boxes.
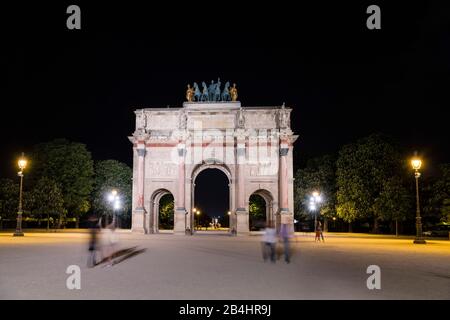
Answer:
[0,139,132,228]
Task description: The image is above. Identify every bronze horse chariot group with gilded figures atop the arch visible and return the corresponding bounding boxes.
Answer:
[186,78,237,102]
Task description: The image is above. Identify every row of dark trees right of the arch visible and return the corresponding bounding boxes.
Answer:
[294,134,450,234]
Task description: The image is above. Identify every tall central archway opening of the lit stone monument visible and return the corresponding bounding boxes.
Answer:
[191,164,233,231]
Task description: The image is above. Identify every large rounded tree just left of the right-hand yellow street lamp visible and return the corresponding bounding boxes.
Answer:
[336,134,410,232]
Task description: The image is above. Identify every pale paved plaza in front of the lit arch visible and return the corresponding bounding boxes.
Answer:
[0,232,450,299]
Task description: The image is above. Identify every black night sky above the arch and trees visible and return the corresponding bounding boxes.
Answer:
[0,1,450,215]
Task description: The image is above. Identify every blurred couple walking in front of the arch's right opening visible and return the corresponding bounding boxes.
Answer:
[262,223,294,263]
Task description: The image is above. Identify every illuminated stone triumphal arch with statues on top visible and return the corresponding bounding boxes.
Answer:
[129,80,298,235]
